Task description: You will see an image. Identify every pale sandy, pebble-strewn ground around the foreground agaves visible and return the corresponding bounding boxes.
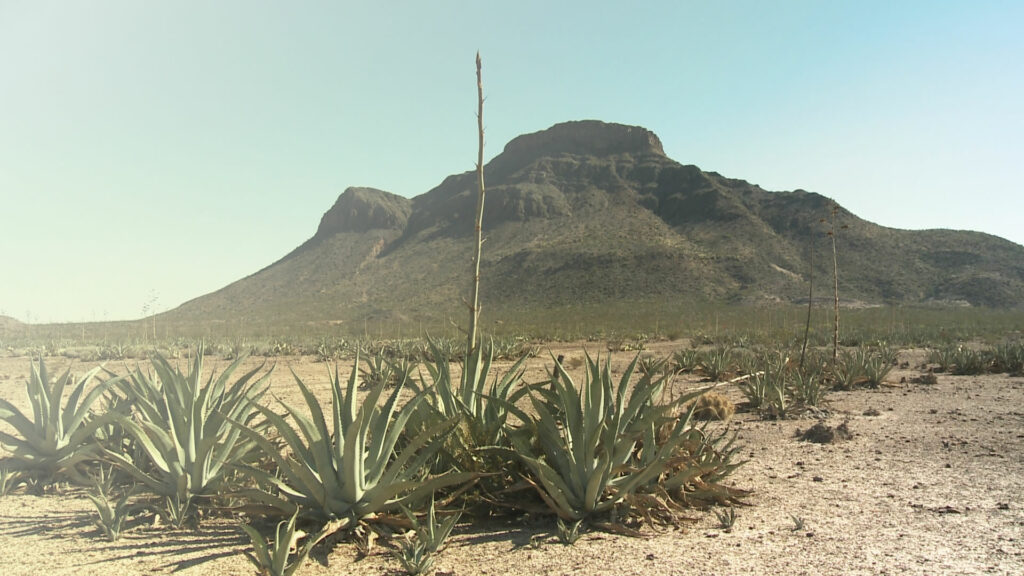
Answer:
[0,342,1024,576]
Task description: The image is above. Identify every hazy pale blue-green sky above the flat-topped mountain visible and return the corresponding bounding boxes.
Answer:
[0,0,1024,322]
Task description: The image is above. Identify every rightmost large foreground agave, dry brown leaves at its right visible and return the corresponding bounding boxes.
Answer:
[511,355,699,522]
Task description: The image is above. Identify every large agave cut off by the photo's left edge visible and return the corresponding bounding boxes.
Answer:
[0,359,118,484]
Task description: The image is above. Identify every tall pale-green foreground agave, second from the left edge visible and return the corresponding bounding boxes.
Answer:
[105,346,270,526]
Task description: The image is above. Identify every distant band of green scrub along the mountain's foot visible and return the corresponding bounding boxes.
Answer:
[0,301,1024,359]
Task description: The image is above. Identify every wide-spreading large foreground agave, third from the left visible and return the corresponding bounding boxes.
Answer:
[237,355,474,529]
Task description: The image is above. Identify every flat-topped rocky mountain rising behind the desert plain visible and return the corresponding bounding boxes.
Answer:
[167,121,1024,330]
